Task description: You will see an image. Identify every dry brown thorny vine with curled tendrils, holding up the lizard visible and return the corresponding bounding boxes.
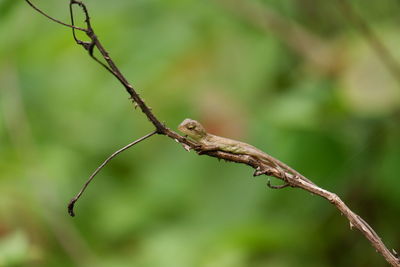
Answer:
[25,0,400,267]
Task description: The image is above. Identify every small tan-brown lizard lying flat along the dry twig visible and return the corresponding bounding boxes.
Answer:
[178,119,314,187]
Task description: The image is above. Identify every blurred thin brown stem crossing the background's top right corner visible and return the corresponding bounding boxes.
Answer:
[337,0,400,82]
